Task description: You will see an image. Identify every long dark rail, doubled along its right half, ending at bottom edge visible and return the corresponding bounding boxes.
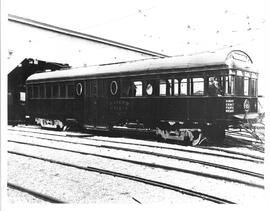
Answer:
[8,151,235,204]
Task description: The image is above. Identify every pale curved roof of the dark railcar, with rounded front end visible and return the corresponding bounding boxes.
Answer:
[27,50,253,82]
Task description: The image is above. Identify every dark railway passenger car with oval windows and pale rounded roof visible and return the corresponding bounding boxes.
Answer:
[26,50,258,145]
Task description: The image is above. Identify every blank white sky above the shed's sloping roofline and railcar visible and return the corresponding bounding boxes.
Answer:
[6,0,269,55]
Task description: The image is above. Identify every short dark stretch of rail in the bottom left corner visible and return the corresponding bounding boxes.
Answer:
[7,182,67,204]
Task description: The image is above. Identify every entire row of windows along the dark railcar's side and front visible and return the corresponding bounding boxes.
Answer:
[27,76,256,98]
